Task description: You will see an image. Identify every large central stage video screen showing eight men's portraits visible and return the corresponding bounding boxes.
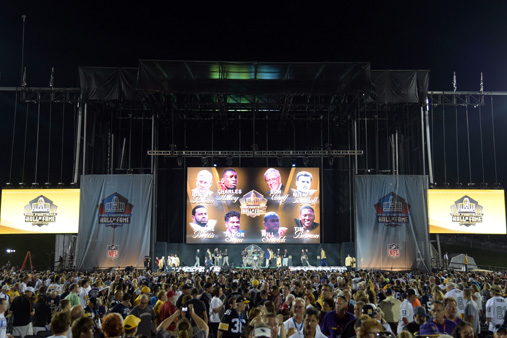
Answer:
[186,167,320,244]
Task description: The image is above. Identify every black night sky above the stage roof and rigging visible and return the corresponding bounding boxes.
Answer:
[0,1,507,90]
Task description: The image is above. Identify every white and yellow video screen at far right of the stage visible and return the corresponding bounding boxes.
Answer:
[428,189,506,234]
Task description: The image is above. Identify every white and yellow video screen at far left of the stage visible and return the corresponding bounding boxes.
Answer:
[0,189,79,234]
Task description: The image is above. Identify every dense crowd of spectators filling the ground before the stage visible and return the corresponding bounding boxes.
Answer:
[0,269,507,338]
